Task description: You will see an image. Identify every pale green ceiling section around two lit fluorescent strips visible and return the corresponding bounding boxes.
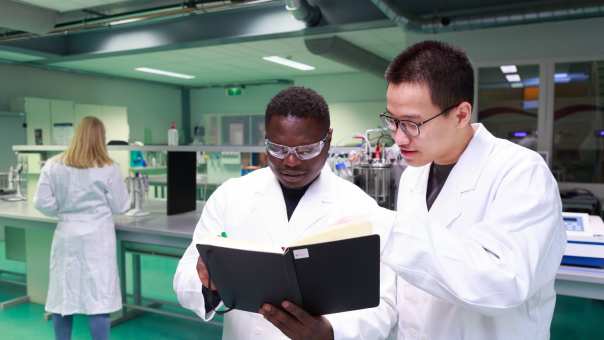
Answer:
[53,37,355,86]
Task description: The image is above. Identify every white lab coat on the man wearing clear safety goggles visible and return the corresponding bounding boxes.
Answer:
[174,168,396,340]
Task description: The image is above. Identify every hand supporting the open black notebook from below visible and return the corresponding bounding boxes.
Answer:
[258,301,333,340]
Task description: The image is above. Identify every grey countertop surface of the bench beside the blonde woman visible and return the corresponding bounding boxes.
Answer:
[0,200,203,239]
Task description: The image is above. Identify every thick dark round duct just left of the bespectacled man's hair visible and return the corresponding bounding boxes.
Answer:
[304,36,389,78]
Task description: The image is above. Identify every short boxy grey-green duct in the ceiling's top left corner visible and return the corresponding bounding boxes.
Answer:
[0,0,59,34]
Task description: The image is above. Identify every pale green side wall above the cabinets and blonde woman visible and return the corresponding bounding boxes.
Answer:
[0,64,182,147]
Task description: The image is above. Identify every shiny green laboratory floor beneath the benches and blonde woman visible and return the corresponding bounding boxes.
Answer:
[0,241,604,340]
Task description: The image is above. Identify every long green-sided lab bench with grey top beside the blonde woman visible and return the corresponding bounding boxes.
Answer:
[0,200,212,324]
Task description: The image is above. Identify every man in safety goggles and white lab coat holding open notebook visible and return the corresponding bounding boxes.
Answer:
[174,87,396,340]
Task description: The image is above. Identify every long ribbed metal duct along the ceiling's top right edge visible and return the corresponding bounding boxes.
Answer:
[371,0,604,33]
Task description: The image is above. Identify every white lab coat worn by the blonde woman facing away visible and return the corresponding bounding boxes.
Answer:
[34,158,130,315]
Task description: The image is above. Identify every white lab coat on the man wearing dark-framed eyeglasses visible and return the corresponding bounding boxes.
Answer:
[383,124,566,340]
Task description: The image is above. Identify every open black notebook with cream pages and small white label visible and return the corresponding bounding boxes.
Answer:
[197,224,380,315]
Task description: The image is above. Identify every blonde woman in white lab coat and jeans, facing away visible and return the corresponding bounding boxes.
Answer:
[34,117,130,340]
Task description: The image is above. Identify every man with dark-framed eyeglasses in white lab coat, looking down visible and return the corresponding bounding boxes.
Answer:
[382,41,566,340]
